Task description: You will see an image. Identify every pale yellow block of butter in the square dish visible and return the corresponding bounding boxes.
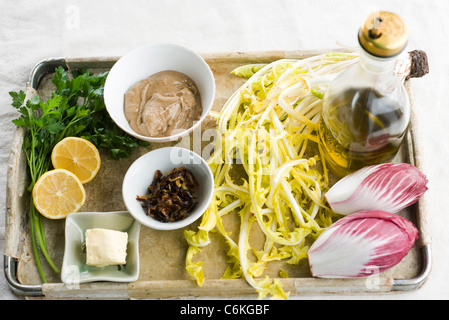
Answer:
[86,228,128,268]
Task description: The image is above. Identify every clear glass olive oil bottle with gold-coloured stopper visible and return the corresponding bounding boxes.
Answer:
[319,11,410,176]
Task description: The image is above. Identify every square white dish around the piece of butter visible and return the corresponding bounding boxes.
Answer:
[61,211,140,285]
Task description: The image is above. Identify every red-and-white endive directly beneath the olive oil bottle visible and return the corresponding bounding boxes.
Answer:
[325,163,427,215]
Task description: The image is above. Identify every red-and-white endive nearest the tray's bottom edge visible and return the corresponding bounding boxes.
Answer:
[308,211,418,278]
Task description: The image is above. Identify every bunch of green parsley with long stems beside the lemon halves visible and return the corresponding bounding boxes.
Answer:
[9,67,148,282]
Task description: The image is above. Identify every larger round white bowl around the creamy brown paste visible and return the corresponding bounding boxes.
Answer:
[104,44,215,143]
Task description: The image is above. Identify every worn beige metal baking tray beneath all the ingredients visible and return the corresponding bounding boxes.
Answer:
[4,50,431,299]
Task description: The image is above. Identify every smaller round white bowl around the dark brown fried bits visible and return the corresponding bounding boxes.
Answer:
[122,147,214,230]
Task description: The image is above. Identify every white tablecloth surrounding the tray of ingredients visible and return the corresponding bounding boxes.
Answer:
[0,0,449,299]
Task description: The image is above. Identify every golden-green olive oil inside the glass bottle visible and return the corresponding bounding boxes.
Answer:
[319,88,408,176]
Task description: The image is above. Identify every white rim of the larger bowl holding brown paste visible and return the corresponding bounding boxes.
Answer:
[103,42,216,143]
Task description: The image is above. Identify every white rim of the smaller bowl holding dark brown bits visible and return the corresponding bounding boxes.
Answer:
[122,147,214,231]
